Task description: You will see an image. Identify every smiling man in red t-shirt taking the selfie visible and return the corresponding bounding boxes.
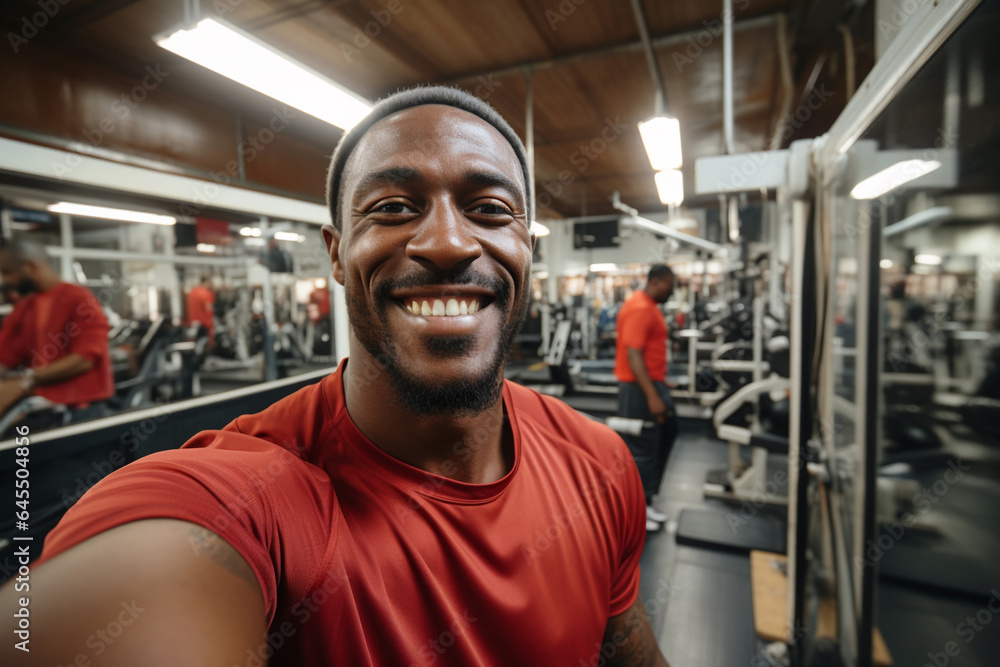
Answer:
[0,88,666,667]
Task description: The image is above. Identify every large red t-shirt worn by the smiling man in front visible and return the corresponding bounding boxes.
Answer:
[35,363,645,667]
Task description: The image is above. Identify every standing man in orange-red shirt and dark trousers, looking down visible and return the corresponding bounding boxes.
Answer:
[615,264,677,530]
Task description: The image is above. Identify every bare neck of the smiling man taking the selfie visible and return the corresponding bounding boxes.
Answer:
[343,353,514,484]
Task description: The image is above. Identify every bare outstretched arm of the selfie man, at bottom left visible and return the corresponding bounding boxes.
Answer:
[0,519,267,667]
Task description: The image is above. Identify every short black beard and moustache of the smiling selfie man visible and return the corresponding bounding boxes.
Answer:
[345,269,529,416]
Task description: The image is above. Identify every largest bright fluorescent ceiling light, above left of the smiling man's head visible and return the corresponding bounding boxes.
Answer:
[153,19,372,130]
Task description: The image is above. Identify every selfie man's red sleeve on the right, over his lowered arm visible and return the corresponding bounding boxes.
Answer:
[608,439,646,617]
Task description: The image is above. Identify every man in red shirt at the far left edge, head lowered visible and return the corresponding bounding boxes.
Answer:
[0,241,114,422]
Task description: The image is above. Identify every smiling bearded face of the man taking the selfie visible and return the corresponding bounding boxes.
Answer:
[324,105,534,414]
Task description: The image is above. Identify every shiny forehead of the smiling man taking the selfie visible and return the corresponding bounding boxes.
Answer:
[344,104,524,187]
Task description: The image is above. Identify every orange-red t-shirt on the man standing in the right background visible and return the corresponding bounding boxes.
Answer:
[615,290,667,382]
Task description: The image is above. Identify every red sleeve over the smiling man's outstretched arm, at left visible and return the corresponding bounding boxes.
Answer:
[39,433,329,624]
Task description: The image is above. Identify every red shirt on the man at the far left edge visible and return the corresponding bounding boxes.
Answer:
[0,283,114,405]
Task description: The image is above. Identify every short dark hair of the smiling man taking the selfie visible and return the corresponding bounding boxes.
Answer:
[326,86,535,229]
